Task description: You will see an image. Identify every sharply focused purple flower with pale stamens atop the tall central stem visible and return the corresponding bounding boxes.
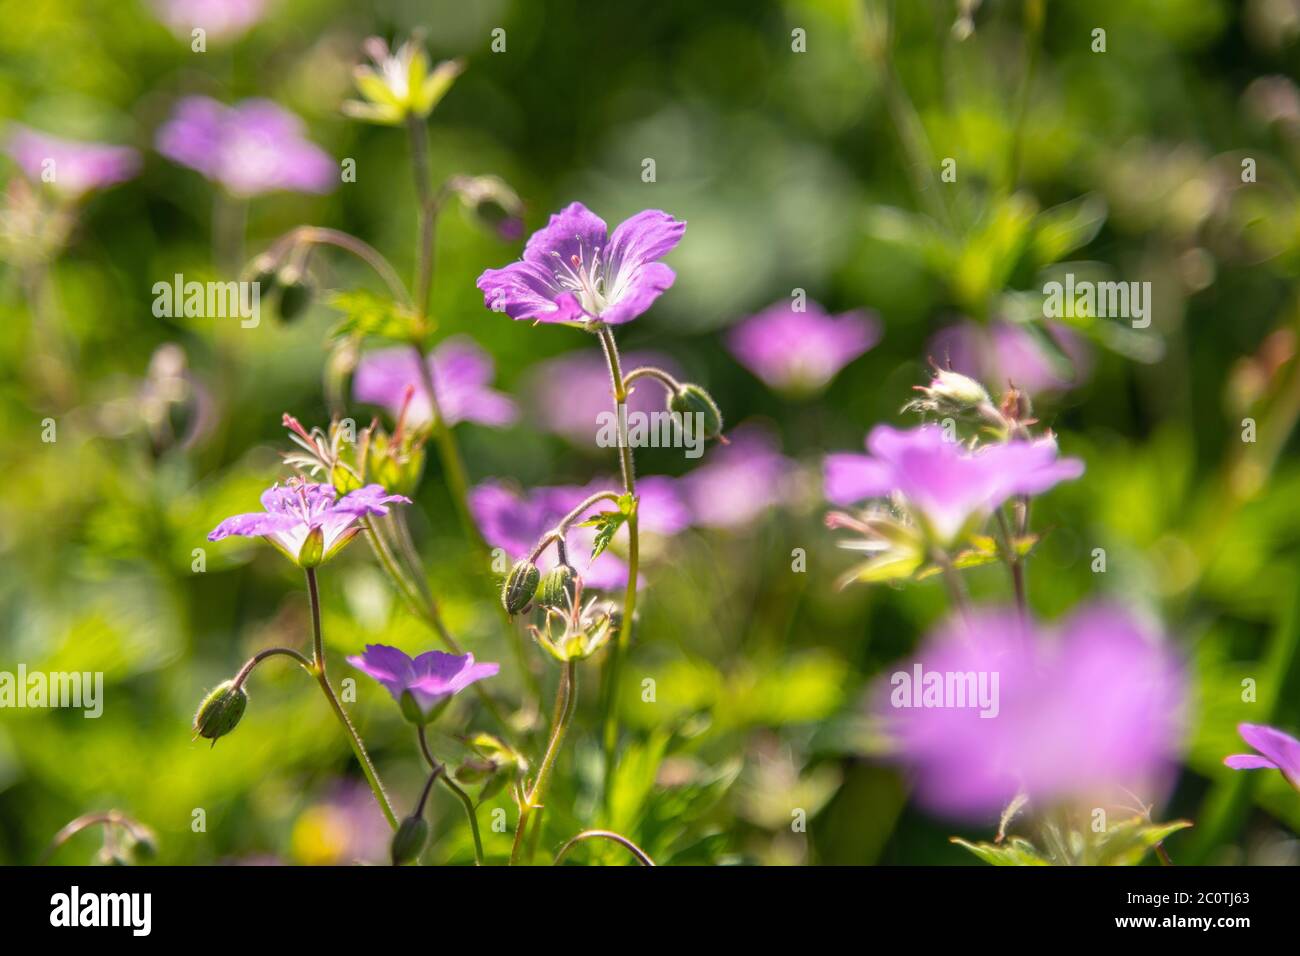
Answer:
[478,203,686,325]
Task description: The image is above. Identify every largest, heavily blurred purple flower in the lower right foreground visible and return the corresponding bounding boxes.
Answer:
[875,606,1186,818]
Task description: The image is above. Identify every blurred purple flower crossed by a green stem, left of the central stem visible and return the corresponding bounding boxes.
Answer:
[352,336,517,427]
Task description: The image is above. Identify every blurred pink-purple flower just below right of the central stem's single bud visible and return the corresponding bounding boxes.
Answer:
[680,425,794,528]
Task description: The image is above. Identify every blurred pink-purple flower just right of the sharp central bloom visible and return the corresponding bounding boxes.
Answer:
[727,302,880,394]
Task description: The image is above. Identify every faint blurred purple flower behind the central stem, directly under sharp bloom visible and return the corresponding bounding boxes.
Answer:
[528,349,681,447]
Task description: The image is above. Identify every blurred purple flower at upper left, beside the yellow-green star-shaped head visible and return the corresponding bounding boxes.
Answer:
[157,96,338,196]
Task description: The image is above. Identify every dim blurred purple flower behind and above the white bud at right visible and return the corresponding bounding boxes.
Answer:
[930,321,1092,395]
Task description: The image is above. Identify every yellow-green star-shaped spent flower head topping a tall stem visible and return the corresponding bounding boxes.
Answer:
[343,36,465,126]
